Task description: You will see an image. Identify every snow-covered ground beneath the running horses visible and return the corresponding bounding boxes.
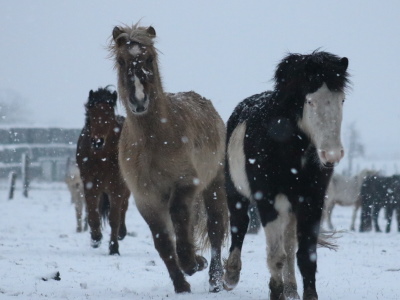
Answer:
[0,183,400,300]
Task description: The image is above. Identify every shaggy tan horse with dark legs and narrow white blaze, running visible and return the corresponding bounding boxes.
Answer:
[110,24,228,293]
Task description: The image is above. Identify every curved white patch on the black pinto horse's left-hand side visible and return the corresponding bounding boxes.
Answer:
[228,122,251,199]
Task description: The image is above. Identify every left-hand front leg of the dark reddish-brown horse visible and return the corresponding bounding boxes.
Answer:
[85,190,103,248]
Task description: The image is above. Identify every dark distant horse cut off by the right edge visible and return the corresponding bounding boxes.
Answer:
[360,175,400,233]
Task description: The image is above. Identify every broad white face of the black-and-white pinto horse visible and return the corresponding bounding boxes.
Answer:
[298,83,344,164]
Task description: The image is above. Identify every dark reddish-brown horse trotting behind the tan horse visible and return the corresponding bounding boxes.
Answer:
[76,86,130,255]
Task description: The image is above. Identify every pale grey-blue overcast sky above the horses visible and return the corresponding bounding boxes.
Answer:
[0,0,400,156]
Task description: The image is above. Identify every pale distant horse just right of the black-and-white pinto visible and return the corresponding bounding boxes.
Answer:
[323,169,377,231]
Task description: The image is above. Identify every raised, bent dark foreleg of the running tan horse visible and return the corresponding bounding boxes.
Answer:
[169,185,207,275]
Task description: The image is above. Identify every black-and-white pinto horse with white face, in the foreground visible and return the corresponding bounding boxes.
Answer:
[224,51,349,300]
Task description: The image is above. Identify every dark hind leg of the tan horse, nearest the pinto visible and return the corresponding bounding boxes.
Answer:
[203,174,228,292]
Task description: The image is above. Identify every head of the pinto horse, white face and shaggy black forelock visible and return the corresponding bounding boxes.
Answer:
[275,51,349,167]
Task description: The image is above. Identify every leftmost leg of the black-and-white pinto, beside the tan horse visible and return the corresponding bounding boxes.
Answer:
[223,178,250,291]
